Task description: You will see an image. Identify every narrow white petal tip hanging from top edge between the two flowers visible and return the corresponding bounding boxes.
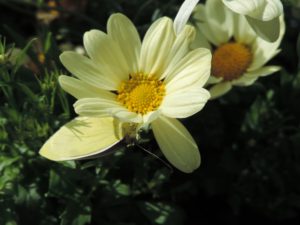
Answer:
[174,0,199,35]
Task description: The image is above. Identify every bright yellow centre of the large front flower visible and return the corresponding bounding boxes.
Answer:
[117,73,166,115]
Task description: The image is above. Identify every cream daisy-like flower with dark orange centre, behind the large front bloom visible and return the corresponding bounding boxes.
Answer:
[193,0,285,99]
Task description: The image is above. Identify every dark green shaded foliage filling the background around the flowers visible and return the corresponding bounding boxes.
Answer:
[0,0,300,225]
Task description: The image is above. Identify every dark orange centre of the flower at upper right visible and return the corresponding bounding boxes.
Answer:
[212,42,252,81]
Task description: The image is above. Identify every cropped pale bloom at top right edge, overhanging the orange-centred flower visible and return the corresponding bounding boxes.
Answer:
[222,0,283,42]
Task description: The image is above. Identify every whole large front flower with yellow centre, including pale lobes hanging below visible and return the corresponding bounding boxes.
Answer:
[40,14,211,173]
